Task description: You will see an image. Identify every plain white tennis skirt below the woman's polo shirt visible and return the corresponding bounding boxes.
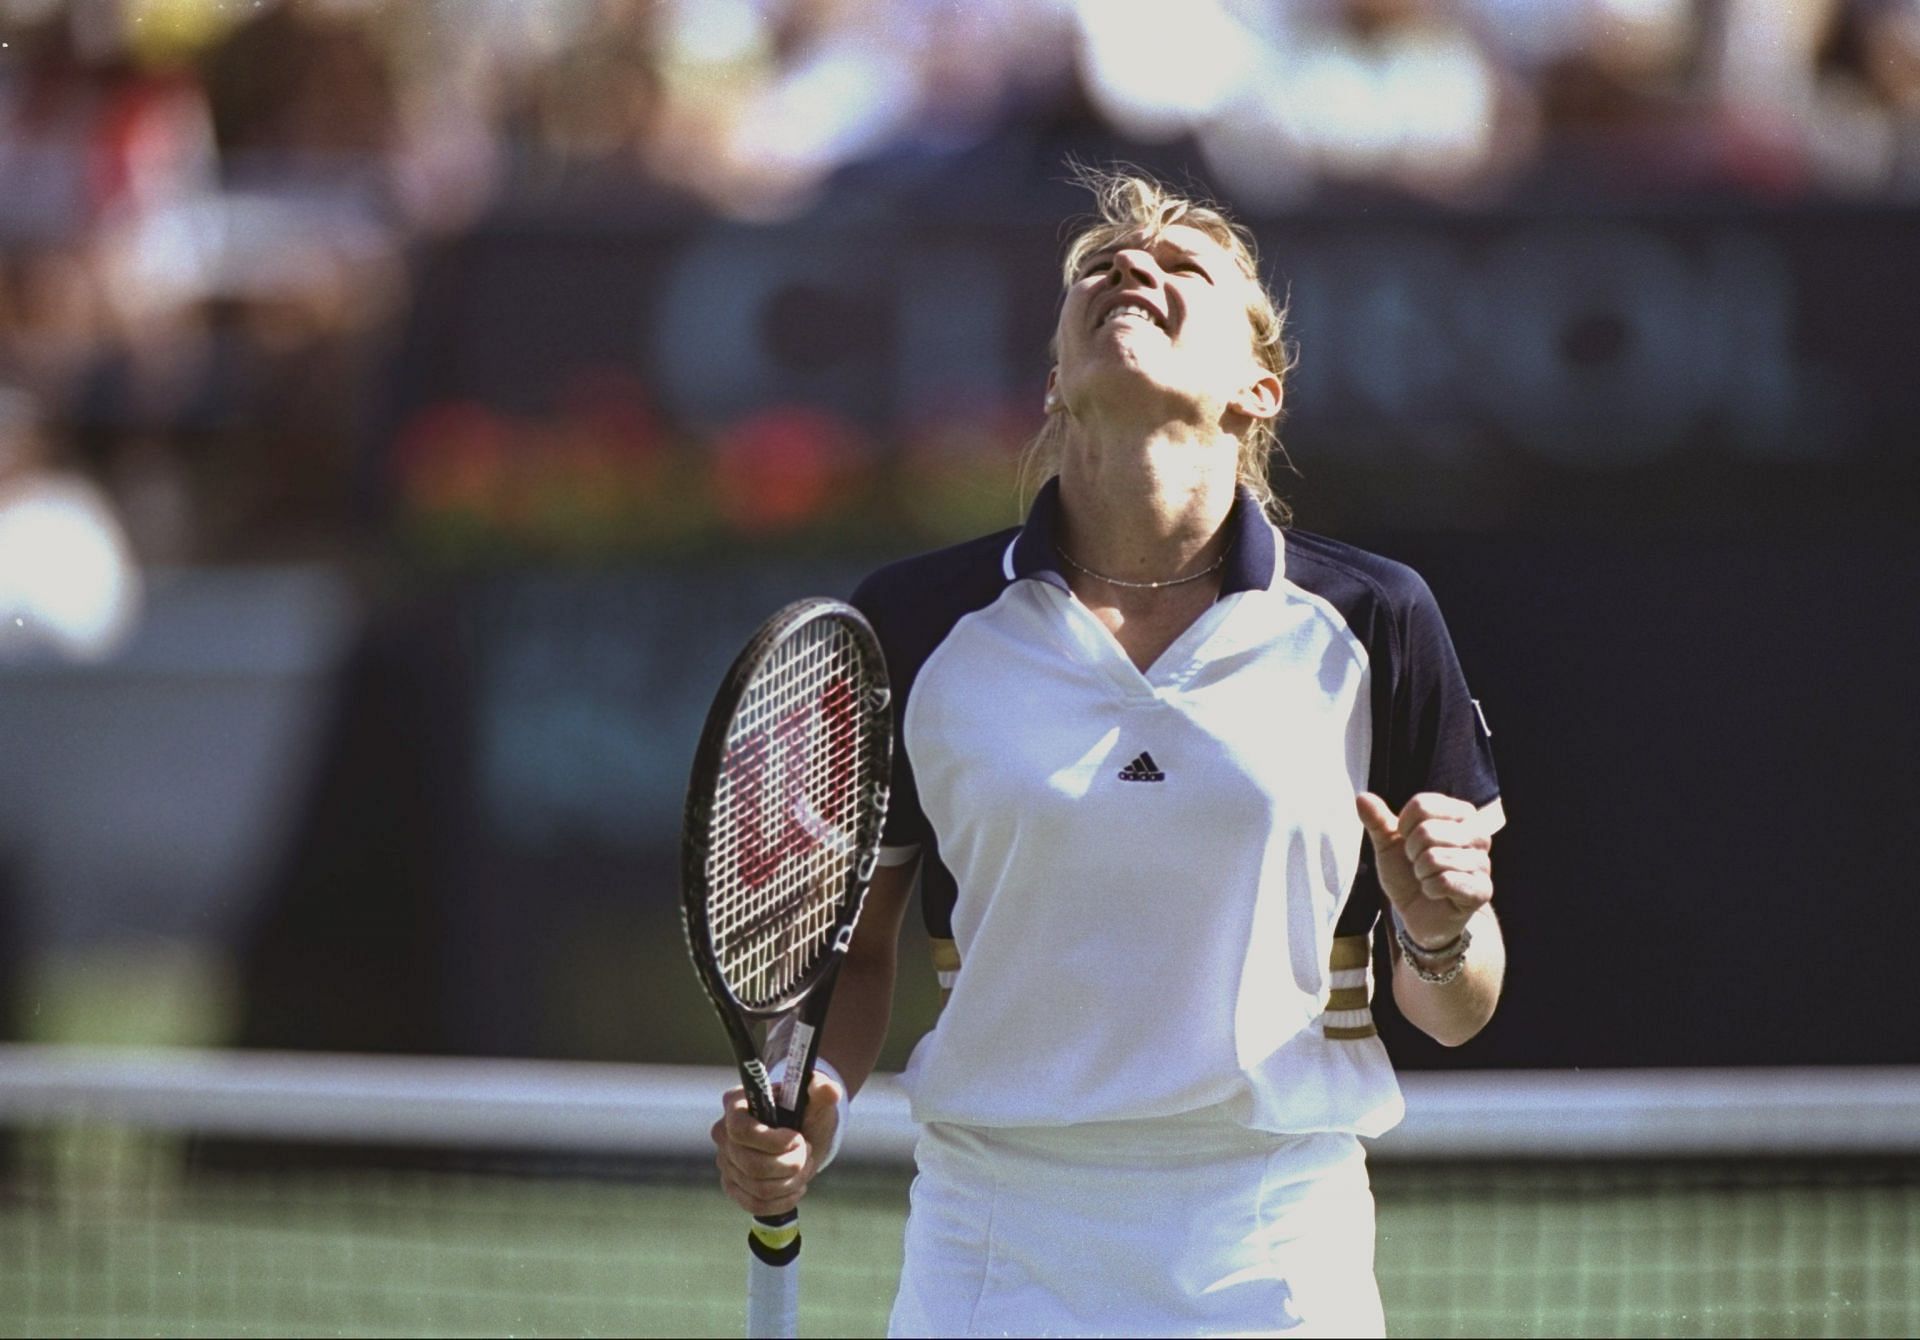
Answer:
[887,1110,1386,1336]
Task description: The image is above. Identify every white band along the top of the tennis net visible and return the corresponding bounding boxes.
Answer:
[0,1044,1920,1163]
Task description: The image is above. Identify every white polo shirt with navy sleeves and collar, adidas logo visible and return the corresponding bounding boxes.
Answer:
[852,482,1500,1135]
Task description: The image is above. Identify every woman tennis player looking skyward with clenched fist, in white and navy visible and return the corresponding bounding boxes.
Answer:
[714,175,1503,1336]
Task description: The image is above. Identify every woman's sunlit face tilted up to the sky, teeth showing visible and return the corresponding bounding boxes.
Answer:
[1050,225,1267,422]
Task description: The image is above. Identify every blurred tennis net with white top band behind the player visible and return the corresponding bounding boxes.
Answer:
[0,1048,1920,1334]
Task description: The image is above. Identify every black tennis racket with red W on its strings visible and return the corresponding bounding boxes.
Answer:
[680,599,893,1336]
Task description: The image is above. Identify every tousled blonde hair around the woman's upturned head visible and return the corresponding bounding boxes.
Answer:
[1020,163,1294,524]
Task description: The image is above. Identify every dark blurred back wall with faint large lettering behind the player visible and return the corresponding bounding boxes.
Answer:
[228,203,1920,1065]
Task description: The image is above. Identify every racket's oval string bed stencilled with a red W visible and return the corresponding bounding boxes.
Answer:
[708,620,870,1008]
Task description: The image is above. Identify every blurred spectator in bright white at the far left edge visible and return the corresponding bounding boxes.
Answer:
[0,386,140,660]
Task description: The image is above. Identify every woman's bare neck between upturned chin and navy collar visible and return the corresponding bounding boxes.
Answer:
[1060,426,1238,582]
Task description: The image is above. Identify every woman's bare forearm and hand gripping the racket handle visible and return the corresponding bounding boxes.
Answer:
[712,860,920,1215]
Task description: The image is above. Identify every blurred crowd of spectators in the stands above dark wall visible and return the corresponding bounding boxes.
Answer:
[0,0,1920,606]
